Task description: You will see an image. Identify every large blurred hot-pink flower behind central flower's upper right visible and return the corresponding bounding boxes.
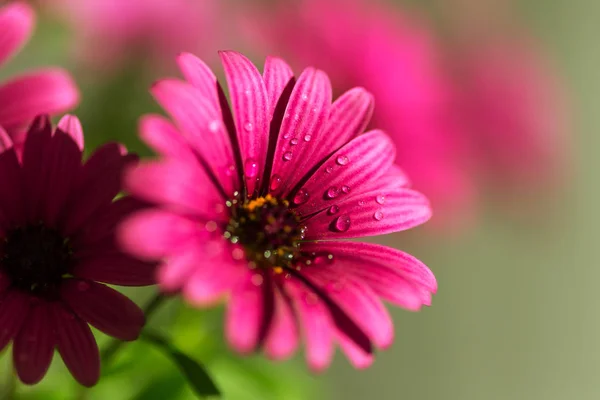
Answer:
[242,0,476,225]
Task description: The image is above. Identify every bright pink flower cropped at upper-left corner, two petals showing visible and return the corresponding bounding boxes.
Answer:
[0,2,79,140]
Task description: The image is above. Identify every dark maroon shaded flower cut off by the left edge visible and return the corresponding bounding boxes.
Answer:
[0,116,154,386]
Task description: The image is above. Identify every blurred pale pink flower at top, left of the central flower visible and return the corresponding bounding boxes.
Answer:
[47,0,220,70]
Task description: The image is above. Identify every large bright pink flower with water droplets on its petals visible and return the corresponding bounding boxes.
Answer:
[120,52,437,370]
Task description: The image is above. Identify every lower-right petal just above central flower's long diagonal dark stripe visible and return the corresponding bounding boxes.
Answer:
[303,268,394,348]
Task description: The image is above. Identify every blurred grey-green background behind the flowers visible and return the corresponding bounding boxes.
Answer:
[0,0,600,400]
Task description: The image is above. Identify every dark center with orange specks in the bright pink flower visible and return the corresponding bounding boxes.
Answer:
[225,195,305,272]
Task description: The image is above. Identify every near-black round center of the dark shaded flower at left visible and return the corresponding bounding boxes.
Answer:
[1,224,73,297]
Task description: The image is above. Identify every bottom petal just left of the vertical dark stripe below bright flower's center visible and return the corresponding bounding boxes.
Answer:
[225,271,264,353]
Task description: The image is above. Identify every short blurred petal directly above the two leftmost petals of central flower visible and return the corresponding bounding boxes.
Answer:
[139,114,194,160]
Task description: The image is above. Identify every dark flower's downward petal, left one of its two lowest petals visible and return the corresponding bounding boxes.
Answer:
[13,302,56,385]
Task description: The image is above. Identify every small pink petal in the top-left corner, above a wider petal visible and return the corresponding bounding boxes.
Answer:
[0,2,35,64]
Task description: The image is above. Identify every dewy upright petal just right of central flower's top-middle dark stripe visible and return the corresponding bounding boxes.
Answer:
[271,68,331,196]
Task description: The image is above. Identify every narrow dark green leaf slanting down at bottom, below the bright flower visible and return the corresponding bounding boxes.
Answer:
[141,331,221,397]
